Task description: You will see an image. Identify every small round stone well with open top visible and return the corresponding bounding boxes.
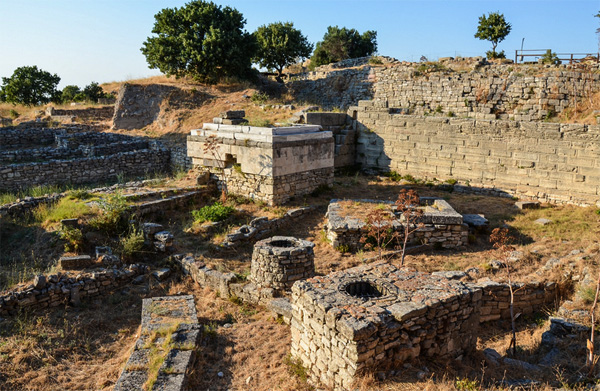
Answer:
[250,236,315,290]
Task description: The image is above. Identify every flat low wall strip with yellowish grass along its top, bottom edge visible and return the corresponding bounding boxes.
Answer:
[114,295,201,391]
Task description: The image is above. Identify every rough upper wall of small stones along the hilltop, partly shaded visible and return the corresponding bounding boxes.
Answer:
[287,58,600,121]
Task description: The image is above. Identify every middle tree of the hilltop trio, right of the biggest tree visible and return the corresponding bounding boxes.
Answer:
[254,22,312,78]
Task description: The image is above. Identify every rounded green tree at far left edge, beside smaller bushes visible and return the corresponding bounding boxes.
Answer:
[0,65,60,106]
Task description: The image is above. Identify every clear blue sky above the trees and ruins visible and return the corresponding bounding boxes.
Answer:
[0,0,600,88]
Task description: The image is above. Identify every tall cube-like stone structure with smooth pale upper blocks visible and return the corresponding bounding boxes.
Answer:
[187,119,334,205]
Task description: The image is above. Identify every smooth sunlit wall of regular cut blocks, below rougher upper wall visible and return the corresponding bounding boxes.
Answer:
[350,101,600,205]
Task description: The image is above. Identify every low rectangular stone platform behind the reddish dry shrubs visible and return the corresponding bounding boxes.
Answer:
[326,197,469,251]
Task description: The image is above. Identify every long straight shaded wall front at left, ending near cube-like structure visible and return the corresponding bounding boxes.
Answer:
[0,142,170,191]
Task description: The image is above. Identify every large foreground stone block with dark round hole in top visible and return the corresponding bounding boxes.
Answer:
[291,261,558,390]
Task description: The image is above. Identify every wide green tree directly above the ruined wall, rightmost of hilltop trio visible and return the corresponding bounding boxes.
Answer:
[310,26,377,68]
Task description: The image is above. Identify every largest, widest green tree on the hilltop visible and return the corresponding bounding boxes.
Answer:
[140,0,255,82]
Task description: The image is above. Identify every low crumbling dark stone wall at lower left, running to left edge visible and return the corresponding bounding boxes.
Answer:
[0,265,147,316]
